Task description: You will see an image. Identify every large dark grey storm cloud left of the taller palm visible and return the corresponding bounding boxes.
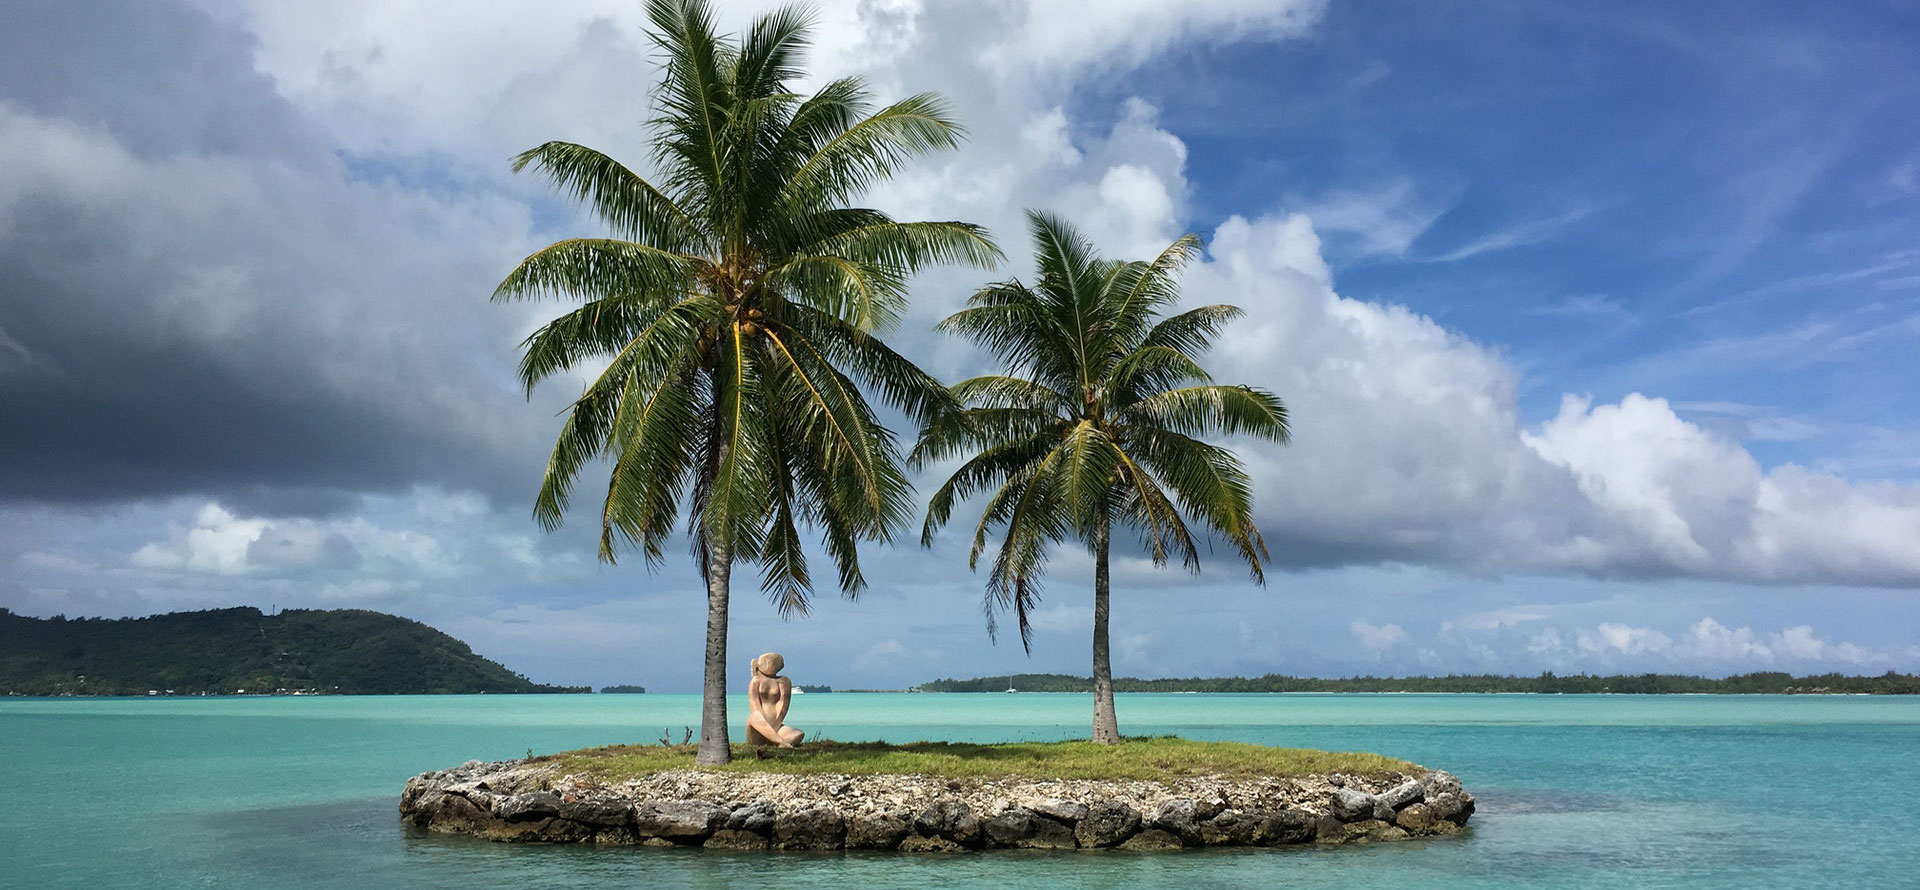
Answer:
[0,2,547,512]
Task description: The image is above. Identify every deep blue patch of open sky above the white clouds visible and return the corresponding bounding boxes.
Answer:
[1110,4,1920,466]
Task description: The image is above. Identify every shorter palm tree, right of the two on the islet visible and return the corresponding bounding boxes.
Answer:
[910,211,1286,744]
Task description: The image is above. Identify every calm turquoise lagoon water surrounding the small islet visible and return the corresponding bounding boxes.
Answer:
[0,694,1920,890]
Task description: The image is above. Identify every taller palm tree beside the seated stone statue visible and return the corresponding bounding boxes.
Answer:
[493,0,998,763]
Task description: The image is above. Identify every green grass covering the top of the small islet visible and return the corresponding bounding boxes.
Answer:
[536,737,1421,783]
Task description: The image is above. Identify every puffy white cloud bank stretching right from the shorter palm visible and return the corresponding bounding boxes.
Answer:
[1187,215,1920,585]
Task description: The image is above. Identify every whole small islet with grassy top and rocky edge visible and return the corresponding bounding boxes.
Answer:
[399,737,1475,852]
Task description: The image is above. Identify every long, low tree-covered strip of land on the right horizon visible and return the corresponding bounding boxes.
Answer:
[918,671,1920,694]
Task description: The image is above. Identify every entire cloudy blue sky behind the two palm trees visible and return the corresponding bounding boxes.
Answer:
[0,0,1920,691]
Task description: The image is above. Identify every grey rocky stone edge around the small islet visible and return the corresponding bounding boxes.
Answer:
[399,760,1473,852]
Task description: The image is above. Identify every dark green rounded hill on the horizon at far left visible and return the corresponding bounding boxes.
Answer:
[0,608,586,694]
